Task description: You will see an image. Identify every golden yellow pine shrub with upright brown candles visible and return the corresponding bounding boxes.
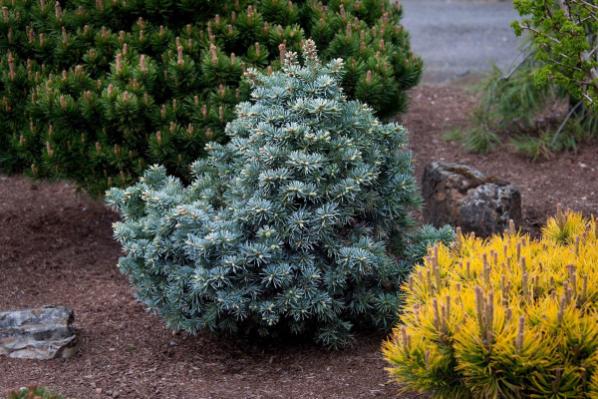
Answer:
[383,212,598,399]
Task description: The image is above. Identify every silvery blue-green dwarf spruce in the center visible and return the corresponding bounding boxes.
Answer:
[107,40,451,348]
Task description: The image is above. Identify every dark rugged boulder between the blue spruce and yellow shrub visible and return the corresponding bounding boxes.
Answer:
[422,162,521,237]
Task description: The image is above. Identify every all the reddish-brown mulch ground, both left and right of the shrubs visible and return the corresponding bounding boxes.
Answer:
[0,86,598,399]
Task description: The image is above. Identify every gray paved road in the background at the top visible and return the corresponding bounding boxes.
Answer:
[400,0,520,83]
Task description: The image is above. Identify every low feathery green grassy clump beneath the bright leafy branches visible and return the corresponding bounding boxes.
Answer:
[458,56,598,159]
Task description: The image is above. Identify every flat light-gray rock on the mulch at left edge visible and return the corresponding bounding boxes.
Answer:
[0,306,77,360]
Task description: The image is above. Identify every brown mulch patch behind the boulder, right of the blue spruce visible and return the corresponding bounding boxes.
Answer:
[403,86,598,233]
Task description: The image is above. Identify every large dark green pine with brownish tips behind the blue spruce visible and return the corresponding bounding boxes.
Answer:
[0,0,421,194]
